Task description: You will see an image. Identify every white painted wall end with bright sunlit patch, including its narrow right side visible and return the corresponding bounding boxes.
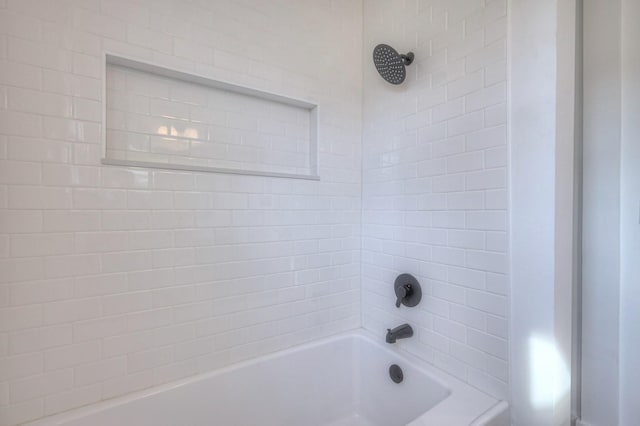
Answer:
[509,0,576,426]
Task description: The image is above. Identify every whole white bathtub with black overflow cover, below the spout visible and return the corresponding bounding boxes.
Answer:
[30,331,508,426]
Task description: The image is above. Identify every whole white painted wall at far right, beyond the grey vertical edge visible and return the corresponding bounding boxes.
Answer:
[581,0,640,426]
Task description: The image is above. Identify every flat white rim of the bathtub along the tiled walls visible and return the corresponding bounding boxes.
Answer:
[22,328,508,426]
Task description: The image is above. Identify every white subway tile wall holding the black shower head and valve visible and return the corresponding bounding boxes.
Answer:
[362,0,509,398]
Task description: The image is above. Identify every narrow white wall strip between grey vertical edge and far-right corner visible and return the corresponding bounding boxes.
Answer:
[581,0,621,426]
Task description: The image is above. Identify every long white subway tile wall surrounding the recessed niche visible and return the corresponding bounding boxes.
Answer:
[0,0,362,425]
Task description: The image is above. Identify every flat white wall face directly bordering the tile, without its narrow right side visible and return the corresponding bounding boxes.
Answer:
[509,1,557,425]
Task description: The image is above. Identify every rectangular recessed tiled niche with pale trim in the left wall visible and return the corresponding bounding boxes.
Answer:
[103,55,319,179]
